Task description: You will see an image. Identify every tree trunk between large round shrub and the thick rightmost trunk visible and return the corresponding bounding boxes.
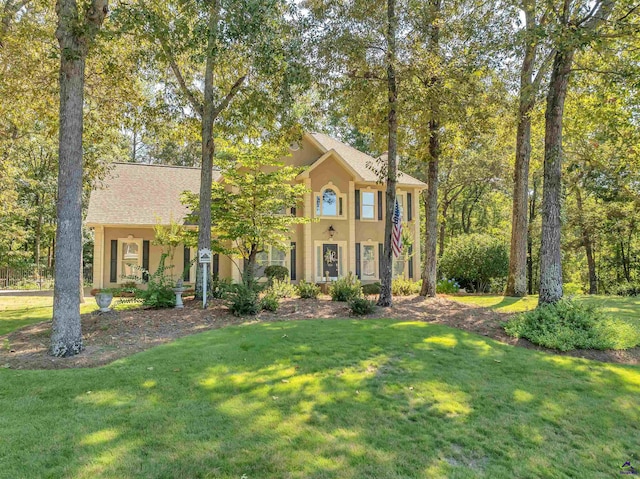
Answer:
[505,2,538,296]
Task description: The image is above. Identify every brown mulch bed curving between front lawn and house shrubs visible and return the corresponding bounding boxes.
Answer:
[0,296,640,369]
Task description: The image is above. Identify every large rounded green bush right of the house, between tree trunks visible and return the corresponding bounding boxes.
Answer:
[439,234,509,292]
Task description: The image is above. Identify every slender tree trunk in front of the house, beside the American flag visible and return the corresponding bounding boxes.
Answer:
[378,0,398,306]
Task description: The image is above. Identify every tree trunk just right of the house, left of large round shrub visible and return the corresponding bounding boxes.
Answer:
[420,0,442,298]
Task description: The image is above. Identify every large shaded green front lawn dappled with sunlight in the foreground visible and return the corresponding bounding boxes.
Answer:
[0,320,640,479]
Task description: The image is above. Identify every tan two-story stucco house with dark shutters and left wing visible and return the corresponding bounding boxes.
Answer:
[86,133,426,288]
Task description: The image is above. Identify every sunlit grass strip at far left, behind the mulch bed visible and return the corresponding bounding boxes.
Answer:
[0,295,138,336]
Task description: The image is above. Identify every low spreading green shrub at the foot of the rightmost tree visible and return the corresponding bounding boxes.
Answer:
[504,299,640,351]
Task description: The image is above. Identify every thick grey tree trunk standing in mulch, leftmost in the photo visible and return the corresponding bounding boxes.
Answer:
[50,0,108,357]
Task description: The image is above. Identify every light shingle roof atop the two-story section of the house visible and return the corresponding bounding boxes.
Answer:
[307,133,427,188]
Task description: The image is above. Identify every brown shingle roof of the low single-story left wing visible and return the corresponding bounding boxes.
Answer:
[85,163,220,225]
